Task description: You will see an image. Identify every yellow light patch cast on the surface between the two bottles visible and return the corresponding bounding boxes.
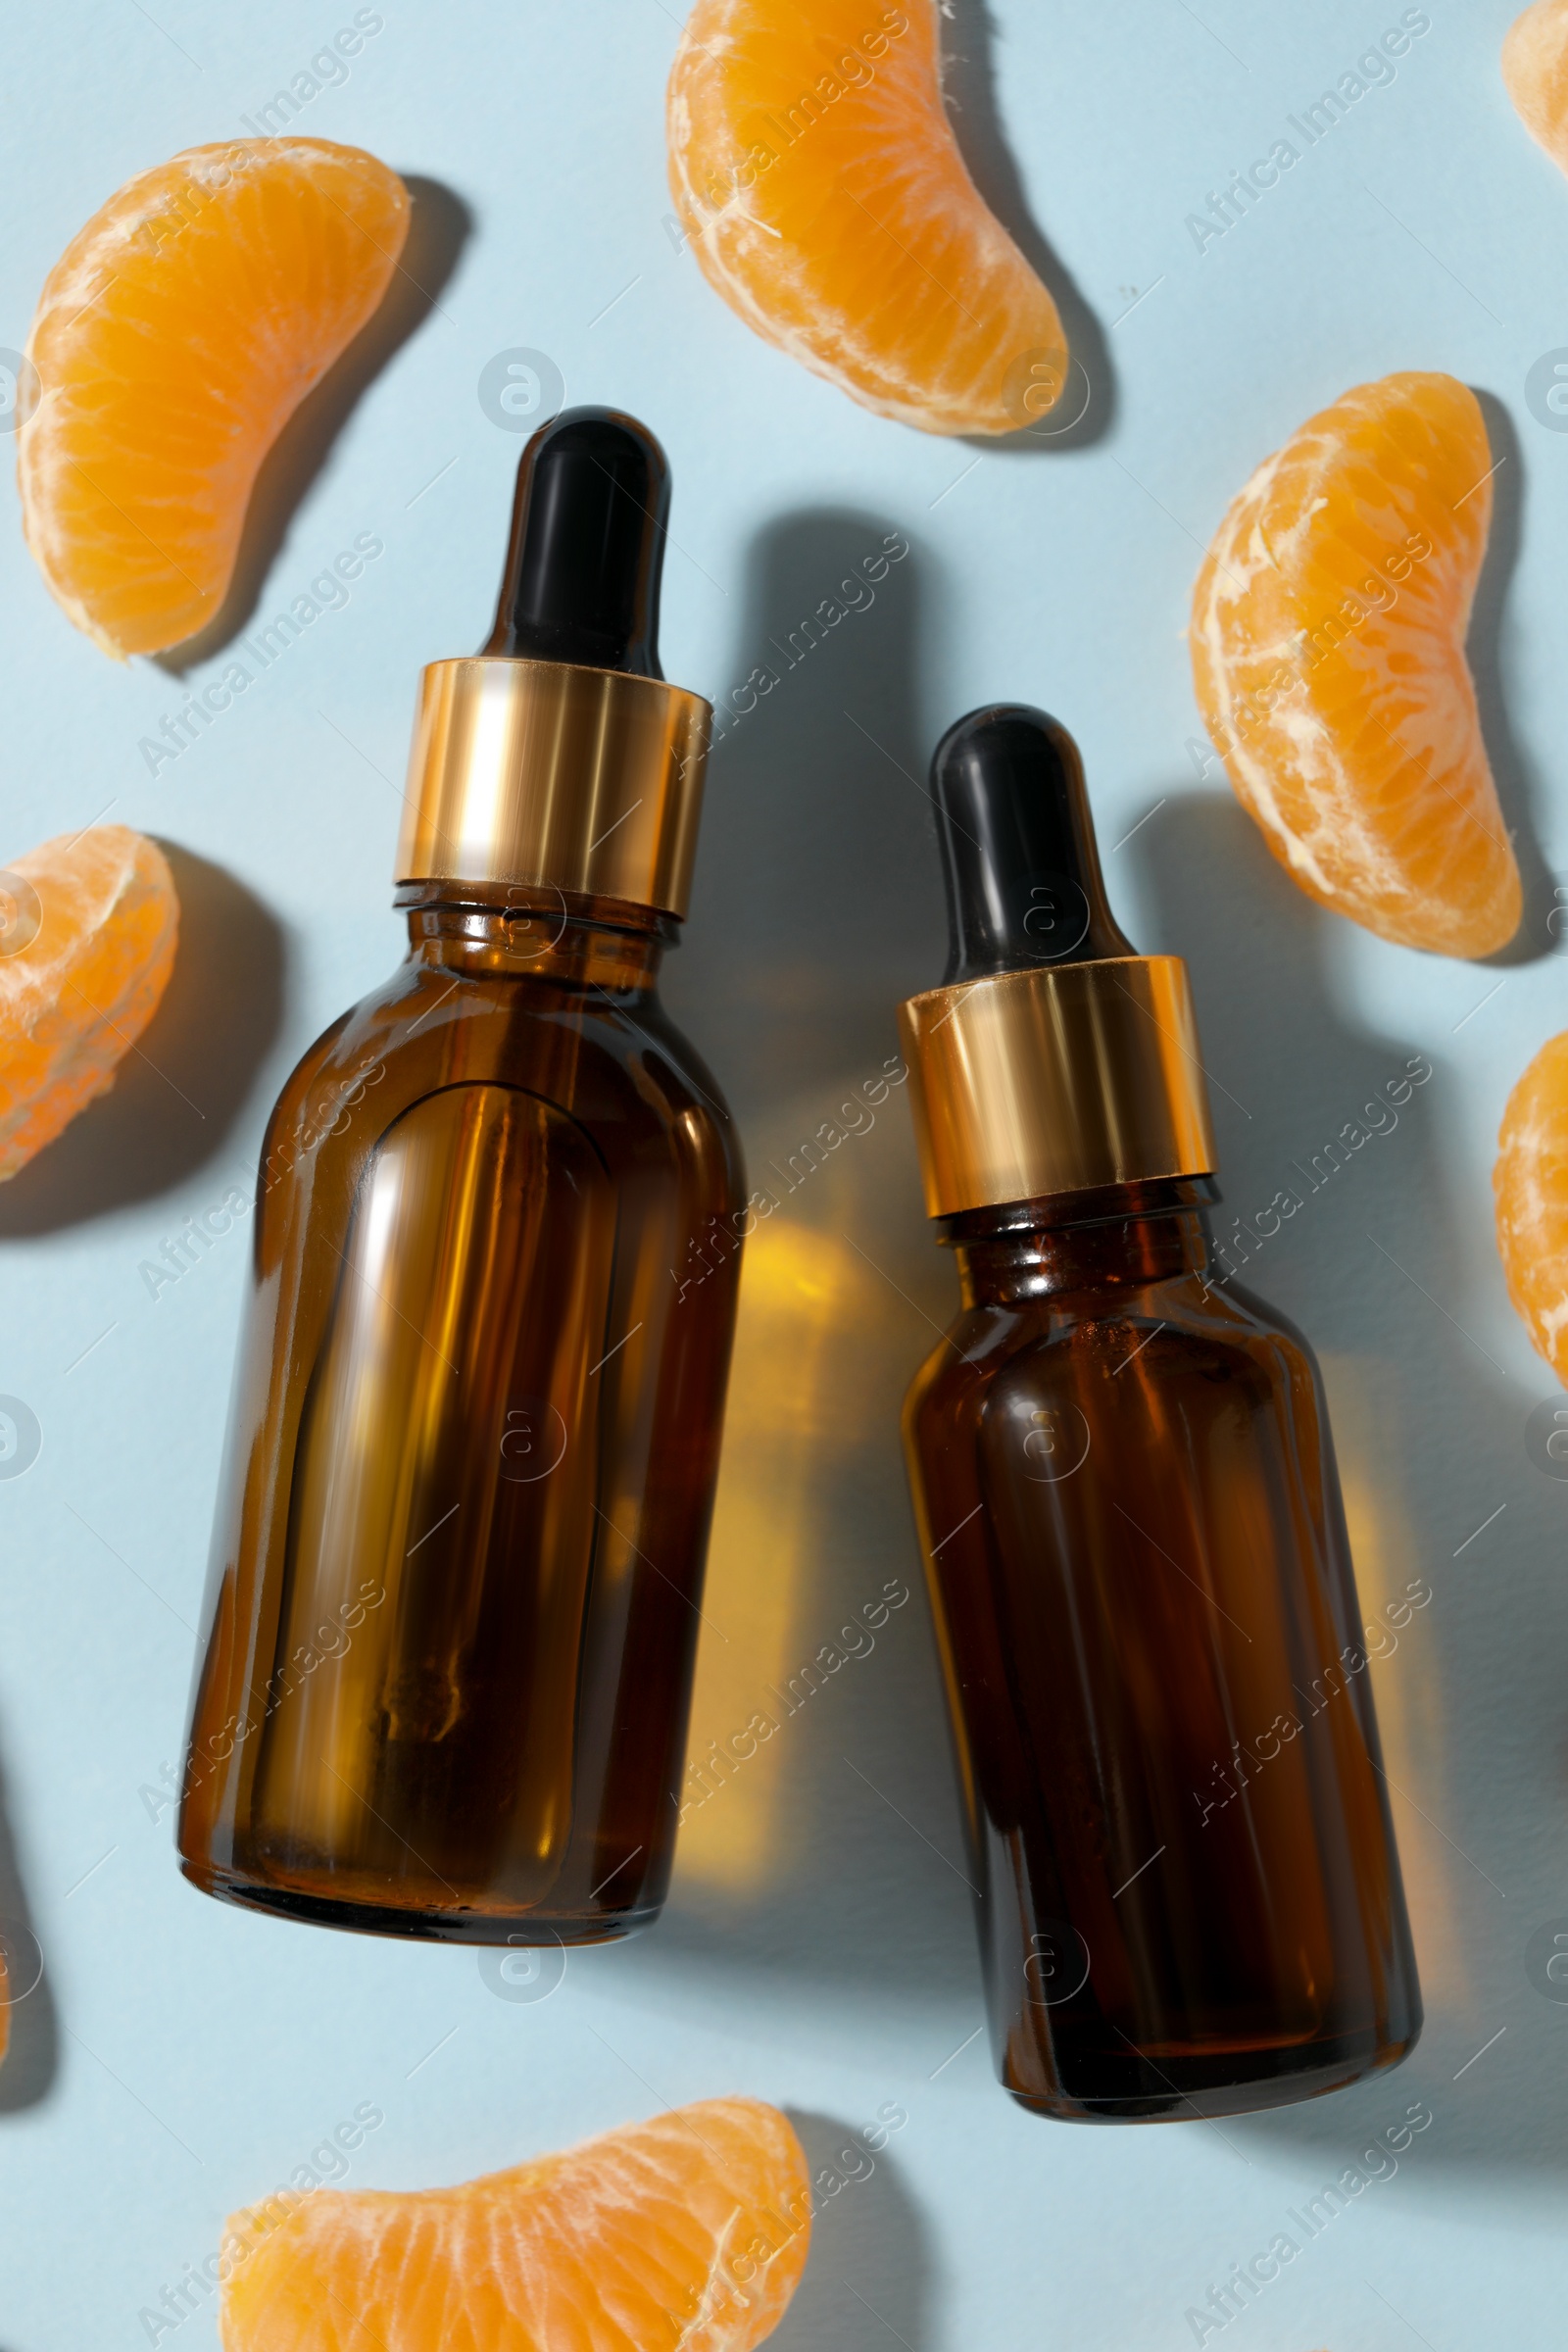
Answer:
[677,1094,940,1898]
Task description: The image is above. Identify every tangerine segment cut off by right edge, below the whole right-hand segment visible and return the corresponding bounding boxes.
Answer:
[1493,1030,1568,1386]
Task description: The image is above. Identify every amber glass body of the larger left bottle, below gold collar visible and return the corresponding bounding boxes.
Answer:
[178,884,743,1942]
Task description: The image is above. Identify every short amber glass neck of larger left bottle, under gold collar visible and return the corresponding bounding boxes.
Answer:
[397,882,679,995]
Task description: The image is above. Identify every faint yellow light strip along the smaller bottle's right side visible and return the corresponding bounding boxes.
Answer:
[1321,1354,1469,2016]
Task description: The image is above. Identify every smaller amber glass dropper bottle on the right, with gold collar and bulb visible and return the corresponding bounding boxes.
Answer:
[901,706,1420,2122]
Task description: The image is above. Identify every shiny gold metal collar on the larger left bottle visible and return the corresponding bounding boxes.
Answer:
[395,654,712,917]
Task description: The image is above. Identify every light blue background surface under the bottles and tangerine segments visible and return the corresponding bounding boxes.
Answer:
[0,0,1568,2352]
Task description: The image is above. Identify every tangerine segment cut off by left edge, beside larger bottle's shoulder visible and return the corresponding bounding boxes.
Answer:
[0,825,178,1183]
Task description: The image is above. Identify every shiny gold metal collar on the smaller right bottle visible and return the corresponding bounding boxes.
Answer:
[898,955,1215,1216]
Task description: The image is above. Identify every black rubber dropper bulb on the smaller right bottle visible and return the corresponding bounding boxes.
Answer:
[931,704,1138,986]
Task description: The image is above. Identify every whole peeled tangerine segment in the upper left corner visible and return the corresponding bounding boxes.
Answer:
[17,139,409,657]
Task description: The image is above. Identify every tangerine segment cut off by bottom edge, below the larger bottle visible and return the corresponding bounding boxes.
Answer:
[219,2098,811,2352]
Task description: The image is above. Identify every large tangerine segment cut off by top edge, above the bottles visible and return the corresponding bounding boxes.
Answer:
[667,0,1067,433]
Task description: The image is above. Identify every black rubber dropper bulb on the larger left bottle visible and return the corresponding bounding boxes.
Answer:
[479,410,670,677]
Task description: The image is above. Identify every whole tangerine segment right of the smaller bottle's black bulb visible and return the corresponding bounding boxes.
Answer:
[1192,374,1521,955]
